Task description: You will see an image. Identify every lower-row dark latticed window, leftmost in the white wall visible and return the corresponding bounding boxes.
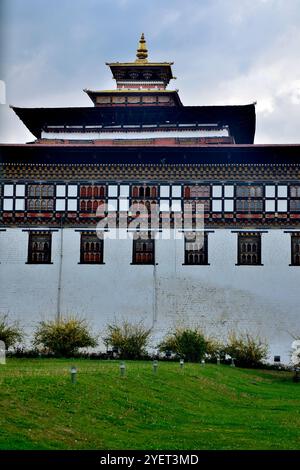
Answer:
[28,232,51,264]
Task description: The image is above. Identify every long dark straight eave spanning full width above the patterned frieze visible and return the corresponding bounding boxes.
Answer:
[0,144,300,166]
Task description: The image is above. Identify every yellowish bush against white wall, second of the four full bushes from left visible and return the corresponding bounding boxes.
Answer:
[103,321,151,359]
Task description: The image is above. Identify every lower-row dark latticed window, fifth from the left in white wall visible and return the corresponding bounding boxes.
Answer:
[238,233,261,265]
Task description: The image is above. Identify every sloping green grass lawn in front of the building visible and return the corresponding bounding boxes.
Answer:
[0,359,300,450]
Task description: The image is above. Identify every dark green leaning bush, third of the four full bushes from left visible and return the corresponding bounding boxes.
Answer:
[158,328,208,362]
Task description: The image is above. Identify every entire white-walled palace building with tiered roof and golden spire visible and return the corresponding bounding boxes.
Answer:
[0,35,300,363]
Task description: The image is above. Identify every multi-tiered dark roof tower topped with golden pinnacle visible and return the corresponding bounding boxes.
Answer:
[13,34,255,146]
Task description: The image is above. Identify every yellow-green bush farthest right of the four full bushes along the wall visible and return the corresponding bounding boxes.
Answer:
[225,332,268,367]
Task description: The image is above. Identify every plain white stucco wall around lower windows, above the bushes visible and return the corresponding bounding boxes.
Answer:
[0,228,300,363]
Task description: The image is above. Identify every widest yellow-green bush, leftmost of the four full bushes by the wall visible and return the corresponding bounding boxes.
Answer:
[33,317,98,357]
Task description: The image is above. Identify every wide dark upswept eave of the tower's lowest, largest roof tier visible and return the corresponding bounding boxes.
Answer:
[12,104,256,144]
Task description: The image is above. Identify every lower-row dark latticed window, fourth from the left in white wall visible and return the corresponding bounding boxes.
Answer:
[184,232,208,265]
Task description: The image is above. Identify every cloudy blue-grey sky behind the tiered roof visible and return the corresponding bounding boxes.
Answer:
[0,0,300,143]
